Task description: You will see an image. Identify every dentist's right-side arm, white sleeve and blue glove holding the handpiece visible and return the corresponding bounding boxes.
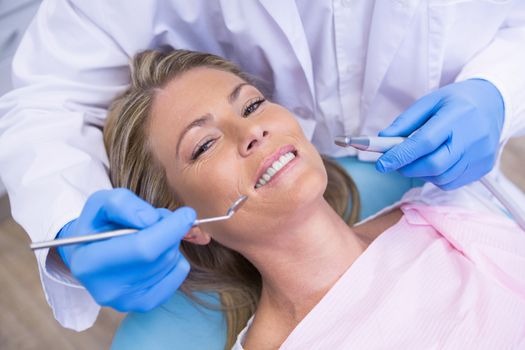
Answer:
[376,1,525,190]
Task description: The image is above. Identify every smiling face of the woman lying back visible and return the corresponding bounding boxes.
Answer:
[148,67,327,252]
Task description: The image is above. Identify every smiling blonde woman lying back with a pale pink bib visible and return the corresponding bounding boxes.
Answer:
[104,50,525,350]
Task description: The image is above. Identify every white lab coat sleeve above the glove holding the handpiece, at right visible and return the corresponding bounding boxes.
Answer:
[456,0,525,144]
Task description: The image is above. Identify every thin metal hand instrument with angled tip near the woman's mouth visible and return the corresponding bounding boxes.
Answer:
[30,195,248,250]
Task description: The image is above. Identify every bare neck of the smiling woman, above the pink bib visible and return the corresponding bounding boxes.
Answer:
[247,199,366,324]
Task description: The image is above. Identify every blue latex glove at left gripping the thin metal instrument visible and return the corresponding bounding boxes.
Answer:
[58,188,196,312]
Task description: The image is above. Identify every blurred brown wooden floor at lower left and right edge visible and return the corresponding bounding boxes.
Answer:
[0,138,525,350]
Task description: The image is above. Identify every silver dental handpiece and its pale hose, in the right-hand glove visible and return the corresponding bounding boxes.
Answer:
[334,136,525,231]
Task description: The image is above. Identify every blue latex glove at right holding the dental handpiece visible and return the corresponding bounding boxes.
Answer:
[376,79,504,190]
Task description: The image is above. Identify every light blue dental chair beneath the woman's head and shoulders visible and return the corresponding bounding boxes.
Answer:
[111,157,423,350]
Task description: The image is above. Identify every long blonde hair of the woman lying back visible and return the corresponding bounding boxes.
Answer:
[104,50,359,349]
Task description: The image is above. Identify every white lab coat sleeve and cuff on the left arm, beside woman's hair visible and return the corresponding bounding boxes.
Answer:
[0,1,140,331]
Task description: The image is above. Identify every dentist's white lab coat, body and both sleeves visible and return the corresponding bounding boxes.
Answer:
[0,0,525,330]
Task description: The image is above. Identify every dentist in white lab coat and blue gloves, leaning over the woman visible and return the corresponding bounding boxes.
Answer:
[0,0,525,342]
